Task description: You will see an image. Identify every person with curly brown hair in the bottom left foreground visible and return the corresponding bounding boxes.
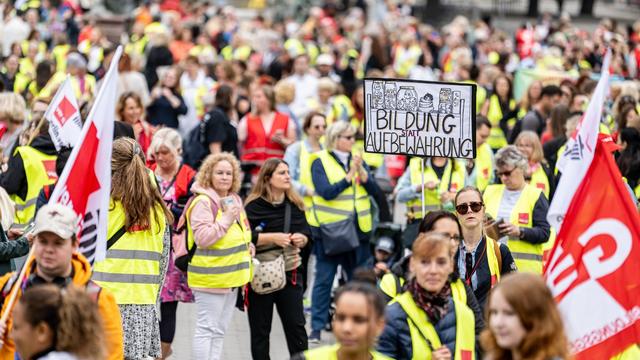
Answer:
[11,284,107,360]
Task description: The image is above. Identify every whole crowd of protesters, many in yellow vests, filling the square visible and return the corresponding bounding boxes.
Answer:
[0,0,640,360]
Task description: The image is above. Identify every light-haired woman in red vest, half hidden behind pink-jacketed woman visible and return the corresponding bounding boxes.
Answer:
[149,128,196,359]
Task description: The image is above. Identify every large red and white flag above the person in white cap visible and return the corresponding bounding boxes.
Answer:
[50,46,122,263]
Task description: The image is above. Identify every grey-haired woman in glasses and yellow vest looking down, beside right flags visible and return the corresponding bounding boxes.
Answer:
[484,145,550,274]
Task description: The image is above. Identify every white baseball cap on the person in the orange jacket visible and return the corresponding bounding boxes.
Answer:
[33,204,79,239]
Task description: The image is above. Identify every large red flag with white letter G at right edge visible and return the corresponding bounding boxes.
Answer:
[545,138,640,360]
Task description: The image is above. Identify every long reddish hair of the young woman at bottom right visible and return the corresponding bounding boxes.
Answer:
[480,273,570,360]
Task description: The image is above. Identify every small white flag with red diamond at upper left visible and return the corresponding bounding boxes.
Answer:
[44,77,82,150]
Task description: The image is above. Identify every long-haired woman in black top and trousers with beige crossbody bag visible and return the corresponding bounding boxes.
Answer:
[245,158,311,359]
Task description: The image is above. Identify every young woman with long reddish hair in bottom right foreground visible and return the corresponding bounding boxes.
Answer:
[481,273,571,360]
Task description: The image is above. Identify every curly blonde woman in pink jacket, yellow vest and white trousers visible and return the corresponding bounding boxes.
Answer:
[183,152,254,360]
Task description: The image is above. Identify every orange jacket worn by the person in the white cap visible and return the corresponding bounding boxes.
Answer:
[0,253,124,360]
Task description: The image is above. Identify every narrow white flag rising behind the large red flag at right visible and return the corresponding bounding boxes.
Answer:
[547,50,611,232]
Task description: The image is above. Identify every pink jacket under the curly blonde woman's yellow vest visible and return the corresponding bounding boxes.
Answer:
[189,182,244,293]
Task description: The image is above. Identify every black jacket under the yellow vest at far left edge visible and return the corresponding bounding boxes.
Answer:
[0,134,57,199]
